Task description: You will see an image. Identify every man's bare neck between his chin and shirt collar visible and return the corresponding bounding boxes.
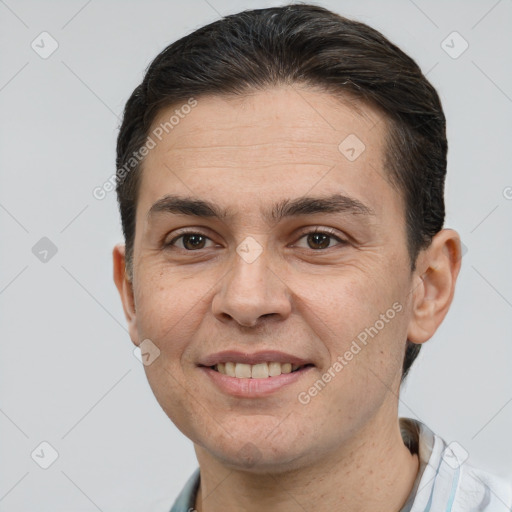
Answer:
[195,419,419,512]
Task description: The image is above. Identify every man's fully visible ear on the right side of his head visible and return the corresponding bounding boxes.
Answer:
[407,229,462,343]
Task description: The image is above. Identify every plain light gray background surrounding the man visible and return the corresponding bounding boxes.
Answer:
[0,0,512,512]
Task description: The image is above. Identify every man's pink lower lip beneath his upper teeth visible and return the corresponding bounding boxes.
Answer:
[198,366,314,398]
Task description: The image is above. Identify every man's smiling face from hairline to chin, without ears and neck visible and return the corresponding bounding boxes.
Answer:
[117,86,424,471]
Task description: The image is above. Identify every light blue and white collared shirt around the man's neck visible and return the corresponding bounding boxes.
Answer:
[166,418,512,512]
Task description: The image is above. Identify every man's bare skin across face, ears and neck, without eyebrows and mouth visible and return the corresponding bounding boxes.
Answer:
[113,85,461,512]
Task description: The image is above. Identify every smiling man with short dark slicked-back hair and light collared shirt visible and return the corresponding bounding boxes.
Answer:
[114,5,512,512]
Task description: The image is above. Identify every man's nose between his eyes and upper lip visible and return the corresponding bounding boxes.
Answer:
[212,241,292,327]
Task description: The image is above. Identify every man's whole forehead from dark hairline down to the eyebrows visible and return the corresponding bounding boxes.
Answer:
[139,85,396,222]
